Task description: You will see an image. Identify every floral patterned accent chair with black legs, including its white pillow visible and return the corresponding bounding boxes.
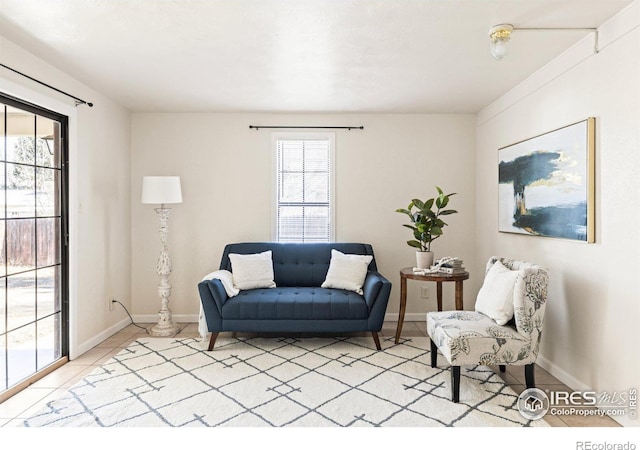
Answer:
[427,256,549,403]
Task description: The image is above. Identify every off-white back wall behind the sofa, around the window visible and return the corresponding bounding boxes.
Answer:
[131,113,475,321]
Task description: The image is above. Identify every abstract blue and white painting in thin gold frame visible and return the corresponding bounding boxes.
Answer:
[498,118,595,242]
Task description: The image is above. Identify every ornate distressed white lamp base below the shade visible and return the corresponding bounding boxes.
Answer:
[147,205,180,337]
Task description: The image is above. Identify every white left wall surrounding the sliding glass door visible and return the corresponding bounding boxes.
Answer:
[0,37,131,358]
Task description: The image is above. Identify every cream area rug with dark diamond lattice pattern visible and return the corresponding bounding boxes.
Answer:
[23,337,548,427]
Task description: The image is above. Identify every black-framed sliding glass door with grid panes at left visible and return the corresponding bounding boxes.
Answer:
[0,95,68,399]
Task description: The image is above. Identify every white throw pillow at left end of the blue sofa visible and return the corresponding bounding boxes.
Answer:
[229,250,276,290]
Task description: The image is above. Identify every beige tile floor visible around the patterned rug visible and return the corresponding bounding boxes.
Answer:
[0,322,620,427]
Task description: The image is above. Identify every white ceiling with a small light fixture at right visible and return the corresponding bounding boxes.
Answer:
[0,0,632,113]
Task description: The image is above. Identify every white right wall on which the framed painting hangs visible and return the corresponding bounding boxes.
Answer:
[474,2,640,426]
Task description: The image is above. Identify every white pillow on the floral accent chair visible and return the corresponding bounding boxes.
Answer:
[476,261,520,325]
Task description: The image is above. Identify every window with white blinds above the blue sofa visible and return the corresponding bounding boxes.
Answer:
[273,133,335,242]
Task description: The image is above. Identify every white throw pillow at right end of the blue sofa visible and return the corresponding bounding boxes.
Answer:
[321,249,373,295]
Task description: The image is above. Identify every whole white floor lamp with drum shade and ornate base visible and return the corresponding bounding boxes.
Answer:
[142,177,182,336]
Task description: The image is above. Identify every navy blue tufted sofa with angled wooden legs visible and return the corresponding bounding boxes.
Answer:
[198,242,391,350]
